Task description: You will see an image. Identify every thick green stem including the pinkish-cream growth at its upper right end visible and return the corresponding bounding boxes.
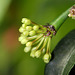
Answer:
[50,4,75,31]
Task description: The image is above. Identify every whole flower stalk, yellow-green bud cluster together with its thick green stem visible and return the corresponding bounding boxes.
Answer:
[19,6,75,63]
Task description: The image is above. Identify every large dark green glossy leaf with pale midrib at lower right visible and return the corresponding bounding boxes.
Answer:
[45,30,75,75]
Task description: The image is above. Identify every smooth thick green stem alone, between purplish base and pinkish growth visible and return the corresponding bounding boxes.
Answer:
[50,4,75,31]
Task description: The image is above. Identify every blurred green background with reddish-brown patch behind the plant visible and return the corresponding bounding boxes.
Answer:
[0,0,75,75]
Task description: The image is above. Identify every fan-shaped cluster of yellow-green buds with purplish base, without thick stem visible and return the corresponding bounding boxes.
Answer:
[18,18,55,63]
